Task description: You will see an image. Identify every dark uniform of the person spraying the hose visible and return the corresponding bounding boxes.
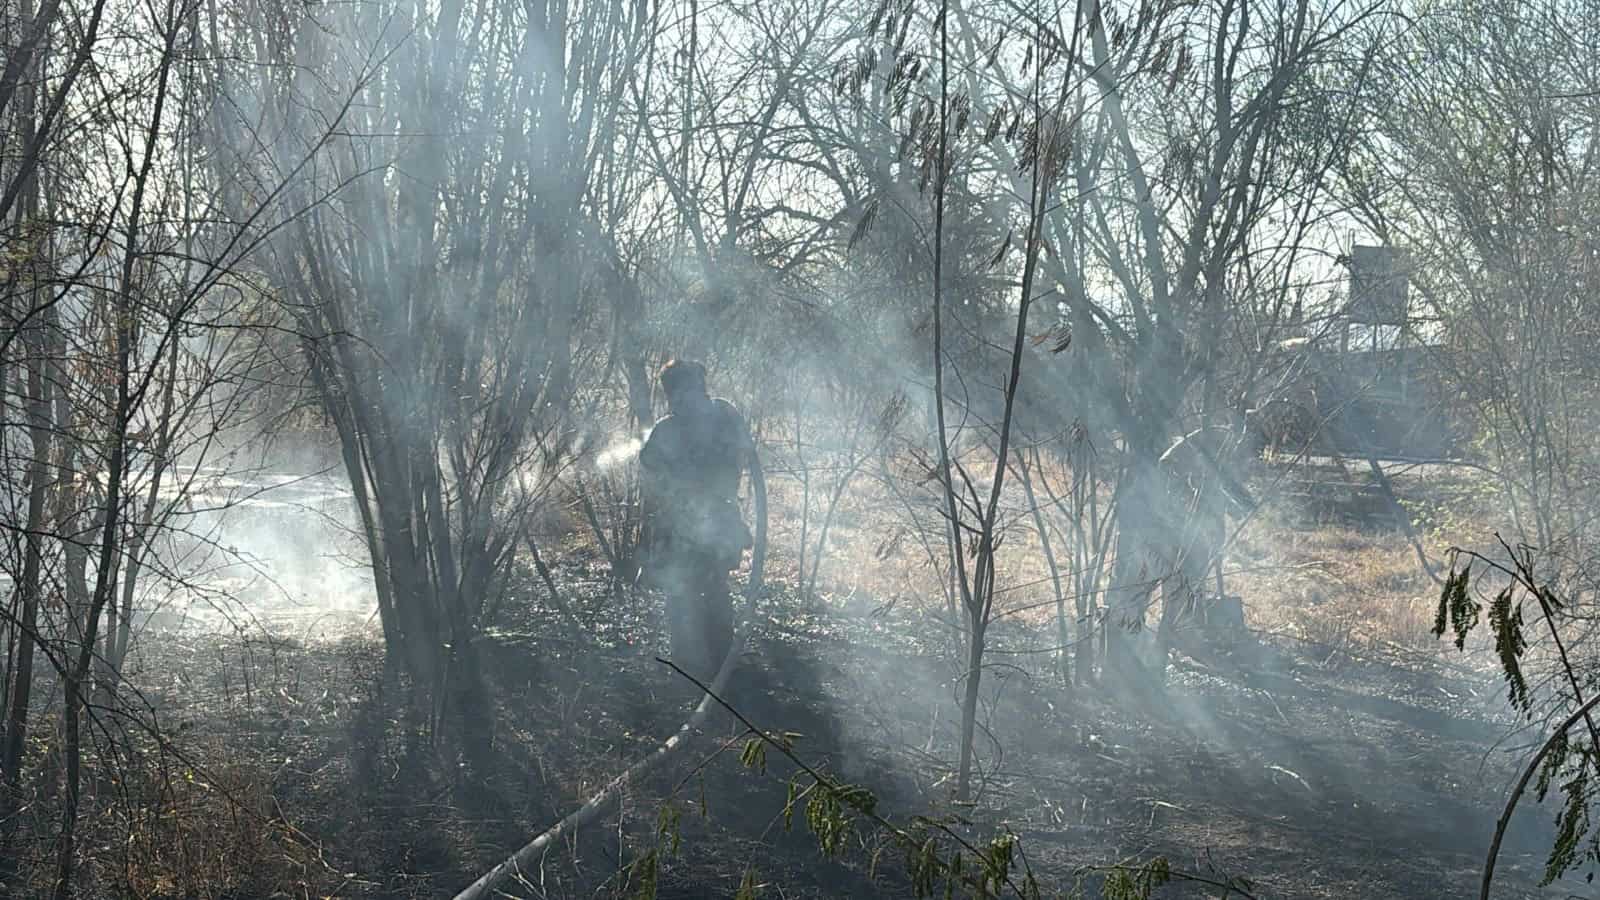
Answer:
[638,396,755,674]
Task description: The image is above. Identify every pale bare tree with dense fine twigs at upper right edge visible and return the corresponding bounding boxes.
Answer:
[1344,2,1600,562]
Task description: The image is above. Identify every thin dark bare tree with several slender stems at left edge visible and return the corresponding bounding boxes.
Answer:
[0,0,396,897]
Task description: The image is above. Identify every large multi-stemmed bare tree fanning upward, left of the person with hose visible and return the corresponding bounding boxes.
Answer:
[211,2,648,759]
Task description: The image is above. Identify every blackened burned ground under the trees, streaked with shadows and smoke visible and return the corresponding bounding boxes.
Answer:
[6,531,1584,898]
